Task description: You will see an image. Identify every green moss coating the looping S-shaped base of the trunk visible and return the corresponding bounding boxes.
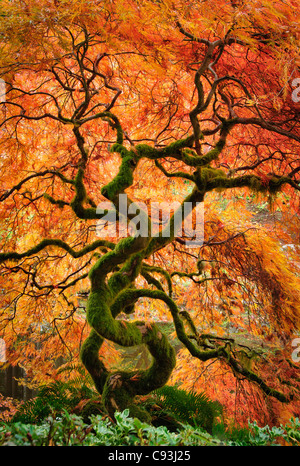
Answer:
[81,276,176,418]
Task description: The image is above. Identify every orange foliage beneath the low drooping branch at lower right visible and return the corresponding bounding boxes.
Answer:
[171,351,300,427]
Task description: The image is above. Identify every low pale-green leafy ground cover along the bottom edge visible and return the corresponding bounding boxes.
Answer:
[0,410,300,446]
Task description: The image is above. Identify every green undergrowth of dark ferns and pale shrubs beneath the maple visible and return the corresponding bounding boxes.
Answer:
[7,380,300,446]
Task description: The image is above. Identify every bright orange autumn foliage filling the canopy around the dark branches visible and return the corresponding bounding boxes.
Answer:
[0,0,300,424]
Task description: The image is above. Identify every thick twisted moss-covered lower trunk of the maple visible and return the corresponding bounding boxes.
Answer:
[81,237,175,417]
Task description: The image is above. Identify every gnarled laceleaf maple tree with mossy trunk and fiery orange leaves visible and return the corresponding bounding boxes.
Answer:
[0,0,300,422]
